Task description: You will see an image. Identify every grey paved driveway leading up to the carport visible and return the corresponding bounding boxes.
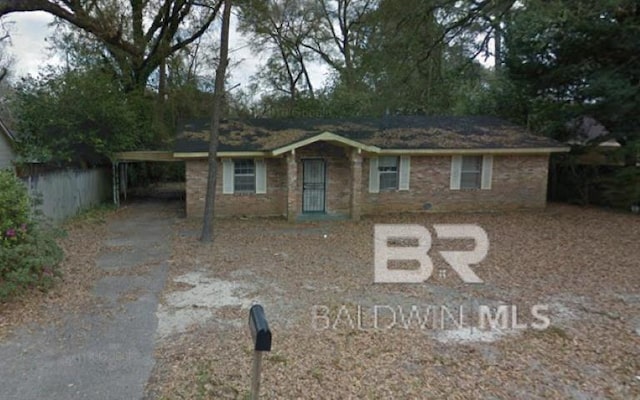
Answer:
[0,202,177,400]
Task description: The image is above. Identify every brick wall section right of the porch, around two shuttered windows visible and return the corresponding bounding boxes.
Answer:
[362,155,549,215]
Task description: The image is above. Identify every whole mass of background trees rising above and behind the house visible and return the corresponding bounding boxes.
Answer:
[0,0,640,208]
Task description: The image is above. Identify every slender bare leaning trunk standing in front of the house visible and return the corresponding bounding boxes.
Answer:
[200,0,231,243]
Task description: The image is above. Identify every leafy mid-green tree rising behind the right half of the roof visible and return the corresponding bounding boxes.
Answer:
[320,0,500,115]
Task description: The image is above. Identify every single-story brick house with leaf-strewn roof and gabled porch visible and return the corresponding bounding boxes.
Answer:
[174,117,569,221]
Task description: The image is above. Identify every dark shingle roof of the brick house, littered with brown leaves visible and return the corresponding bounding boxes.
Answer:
[175,116,563,153]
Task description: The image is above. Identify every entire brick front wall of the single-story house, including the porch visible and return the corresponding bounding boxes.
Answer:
[186,151,548,217]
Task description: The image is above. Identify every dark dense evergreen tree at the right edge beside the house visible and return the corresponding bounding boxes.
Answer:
[505,0,640,208]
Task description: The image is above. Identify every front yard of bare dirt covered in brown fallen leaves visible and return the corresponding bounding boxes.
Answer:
[147,205,640,399]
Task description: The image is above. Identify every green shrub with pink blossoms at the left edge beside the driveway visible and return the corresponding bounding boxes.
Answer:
[0,171,63,300]
